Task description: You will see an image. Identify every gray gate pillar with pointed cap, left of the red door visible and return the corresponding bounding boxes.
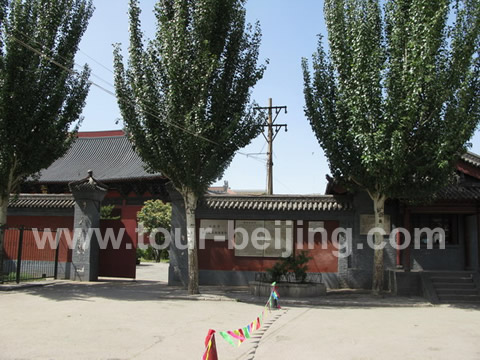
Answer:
[68,170,108,281]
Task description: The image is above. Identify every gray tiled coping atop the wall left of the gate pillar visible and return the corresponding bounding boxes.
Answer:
[8,194,75,209]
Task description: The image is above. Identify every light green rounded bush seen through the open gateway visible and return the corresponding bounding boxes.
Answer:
[137,200,172,262]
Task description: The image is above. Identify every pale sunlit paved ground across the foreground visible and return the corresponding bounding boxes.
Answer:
[0,264,480,360]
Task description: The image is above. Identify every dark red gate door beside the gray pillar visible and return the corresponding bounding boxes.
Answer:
[98,220,137,279]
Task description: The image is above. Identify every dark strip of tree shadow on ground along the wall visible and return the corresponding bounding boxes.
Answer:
[1,279,480,311]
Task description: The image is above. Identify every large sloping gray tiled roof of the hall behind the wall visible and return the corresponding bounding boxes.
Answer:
[38,135,161,183]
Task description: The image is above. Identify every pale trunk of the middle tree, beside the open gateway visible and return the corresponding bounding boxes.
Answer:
[182,189,199,295]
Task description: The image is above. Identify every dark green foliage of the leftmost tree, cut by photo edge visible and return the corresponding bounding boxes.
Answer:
[0,0,93,199]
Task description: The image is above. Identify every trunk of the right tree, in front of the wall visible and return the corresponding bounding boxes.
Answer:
[370,194,385,294]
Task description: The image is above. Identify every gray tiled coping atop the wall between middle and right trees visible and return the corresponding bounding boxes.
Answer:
[203,195,353,211]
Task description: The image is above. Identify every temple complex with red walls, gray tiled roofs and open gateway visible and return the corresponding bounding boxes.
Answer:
[7,131,480,302]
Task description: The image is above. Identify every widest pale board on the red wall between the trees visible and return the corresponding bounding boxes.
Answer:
[235,220,293,257]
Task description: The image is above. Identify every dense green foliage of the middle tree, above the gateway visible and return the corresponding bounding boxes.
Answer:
[115,0,265,198]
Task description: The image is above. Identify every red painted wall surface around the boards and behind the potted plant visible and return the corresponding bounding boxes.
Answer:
[197,221,338,272]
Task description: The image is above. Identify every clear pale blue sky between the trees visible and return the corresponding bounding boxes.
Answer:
[77,0,480,194]
